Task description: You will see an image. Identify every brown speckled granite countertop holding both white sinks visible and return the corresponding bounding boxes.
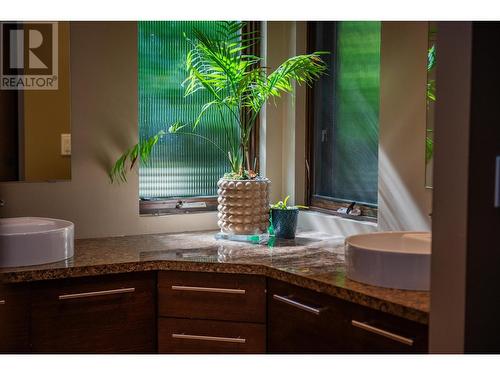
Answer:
[0,232,430,324]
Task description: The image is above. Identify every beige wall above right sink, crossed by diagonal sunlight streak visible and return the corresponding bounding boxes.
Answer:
[378,22,432,231]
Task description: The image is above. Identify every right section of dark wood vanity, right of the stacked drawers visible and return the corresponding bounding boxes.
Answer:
[267,280,427,353]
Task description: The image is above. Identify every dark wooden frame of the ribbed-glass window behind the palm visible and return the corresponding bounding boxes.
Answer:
[139,21,262,216]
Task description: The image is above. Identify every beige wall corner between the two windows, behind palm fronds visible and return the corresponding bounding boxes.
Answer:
[260,21,307,204]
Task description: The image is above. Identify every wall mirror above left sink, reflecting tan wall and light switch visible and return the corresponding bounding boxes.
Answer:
[0,22,71,182]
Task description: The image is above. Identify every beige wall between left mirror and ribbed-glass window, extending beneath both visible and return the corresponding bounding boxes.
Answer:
[0,22,217,238]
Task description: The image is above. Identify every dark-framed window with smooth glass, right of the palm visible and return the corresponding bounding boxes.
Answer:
[308,22,380,220]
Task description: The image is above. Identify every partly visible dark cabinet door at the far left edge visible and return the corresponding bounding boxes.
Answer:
[0,284,30,353]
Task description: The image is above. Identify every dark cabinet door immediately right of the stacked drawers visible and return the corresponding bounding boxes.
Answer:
[267,280,348,353]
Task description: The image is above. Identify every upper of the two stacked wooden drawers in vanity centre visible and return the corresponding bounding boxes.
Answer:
[158,272,266,323]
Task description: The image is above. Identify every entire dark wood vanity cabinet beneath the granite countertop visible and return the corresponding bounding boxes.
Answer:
[0,271,428,354]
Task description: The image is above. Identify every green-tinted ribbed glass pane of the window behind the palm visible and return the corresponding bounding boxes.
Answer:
[138,21,237,198]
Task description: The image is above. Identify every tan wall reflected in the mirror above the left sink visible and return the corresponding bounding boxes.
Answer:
[22,22,71,181]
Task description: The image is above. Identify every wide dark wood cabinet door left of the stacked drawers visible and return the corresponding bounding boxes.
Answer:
[31,273,156,353]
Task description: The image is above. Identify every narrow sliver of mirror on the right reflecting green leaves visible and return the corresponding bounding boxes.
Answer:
[425,22,437,188]
